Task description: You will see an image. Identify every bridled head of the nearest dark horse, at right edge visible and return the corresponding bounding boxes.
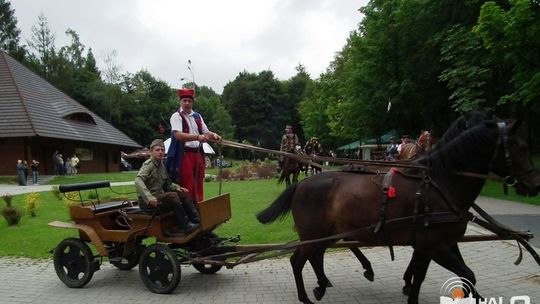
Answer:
[490,121,540,196]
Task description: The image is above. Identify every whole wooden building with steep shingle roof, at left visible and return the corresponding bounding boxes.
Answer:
[0,51,141,175]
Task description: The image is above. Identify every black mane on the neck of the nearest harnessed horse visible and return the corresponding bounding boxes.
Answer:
[418,117,497,174]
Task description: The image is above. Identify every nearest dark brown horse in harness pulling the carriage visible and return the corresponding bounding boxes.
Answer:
[257,114,540,303]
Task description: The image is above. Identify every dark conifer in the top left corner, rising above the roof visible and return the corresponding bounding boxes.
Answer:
[0,0,26,61]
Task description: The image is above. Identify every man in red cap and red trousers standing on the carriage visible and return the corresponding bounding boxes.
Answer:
[166,89,221,202]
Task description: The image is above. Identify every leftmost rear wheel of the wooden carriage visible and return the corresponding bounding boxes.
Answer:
[54,238,95,288]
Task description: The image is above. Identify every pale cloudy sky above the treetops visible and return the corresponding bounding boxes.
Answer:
[10,0,368,93]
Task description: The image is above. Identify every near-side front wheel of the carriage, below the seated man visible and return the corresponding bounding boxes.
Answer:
[139,244,181,294]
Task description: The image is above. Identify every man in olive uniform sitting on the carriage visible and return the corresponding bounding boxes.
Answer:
[135,139,201,236]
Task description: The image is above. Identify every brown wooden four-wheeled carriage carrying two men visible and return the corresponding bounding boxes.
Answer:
[49,181,234,293]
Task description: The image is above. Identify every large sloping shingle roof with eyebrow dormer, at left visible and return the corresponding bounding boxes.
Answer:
[0,52,141,148]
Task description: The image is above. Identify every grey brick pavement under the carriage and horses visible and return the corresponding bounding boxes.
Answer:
[0,227,540,304]
